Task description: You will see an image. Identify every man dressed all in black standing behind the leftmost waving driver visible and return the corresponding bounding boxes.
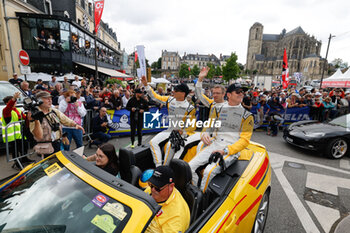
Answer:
[126,88,148,148]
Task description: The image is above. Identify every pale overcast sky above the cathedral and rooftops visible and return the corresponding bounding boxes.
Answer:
[102,0,350,65]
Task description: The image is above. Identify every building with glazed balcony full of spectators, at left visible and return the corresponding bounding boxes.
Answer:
[0,0,123,80]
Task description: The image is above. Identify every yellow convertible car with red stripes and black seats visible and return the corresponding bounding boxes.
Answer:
[0,143,271,233]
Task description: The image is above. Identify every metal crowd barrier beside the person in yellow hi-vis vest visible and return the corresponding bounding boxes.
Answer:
[5,121,34,169]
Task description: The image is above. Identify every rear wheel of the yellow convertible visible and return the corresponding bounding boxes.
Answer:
[252,190,270,233]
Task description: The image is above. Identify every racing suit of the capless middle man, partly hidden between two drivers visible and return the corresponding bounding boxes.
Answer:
[194,81,227,154]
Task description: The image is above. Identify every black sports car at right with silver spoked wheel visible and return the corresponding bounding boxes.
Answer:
[283,114,350,159]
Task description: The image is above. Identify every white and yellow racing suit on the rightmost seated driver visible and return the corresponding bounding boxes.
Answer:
[189,103,254,192]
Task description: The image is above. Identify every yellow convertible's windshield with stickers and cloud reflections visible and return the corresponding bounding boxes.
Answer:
[0,157,131,233]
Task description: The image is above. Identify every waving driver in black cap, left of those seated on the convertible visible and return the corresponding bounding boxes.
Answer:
[141,76,196,166]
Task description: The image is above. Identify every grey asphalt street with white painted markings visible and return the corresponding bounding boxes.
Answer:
[0,131,350,233]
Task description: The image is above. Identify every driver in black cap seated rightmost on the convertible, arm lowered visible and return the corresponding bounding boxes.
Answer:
[189,83,254,191]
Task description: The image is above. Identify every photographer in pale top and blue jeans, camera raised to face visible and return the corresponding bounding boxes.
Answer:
[58,91,86,151]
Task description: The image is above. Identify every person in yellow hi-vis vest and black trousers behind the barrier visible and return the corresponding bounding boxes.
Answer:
[1,92,34,169]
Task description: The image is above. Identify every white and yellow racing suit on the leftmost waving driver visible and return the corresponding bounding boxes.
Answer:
[145,86,196,166]
